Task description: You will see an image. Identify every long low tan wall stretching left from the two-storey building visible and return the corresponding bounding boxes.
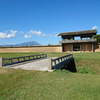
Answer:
[0,45,62,52]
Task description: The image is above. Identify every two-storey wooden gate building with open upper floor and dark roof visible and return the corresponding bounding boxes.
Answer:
[58,30,97,52]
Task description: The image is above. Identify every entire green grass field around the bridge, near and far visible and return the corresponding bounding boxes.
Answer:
[0,53,100,100]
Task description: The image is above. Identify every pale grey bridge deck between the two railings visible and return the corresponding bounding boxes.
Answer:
[5,57,56,71]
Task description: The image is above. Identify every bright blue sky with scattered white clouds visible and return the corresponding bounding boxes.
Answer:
[0,0,100,45]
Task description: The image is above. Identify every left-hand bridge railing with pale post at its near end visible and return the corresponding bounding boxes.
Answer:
[0,53,47,67]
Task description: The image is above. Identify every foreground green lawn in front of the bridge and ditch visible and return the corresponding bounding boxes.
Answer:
[0,69,100,100]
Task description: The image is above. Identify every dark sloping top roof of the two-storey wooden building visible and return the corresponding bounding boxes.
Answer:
[58,30,97,36]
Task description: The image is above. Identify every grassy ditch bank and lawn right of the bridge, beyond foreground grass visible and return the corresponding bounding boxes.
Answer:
[74,52,100,74]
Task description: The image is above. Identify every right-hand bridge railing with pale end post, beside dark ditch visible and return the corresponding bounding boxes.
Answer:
[48,54,74,70]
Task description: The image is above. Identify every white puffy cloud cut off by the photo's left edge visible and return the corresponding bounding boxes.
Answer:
[0,30,17,39]
